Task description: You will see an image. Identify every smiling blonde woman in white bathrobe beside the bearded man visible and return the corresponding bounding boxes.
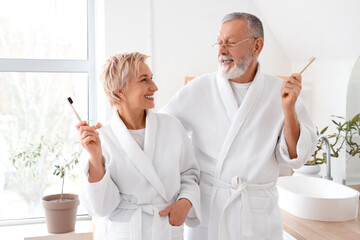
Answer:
[76,52,200,240]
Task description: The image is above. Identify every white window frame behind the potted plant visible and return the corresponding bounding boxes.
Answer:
[0,0,97,226]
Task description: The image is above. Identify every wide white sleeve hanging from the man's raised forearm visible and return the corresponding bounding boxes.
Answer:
[276,98,317,169]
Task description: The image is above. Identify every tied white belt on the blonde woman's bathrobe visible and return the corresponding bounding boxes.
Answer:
[117,201,171,240]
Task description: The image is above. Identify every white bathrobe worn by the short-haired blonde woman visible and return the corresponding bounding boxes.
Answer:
[80,110,200,240]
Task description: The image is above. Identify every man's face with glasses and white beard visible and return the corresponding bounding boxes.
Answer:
[218,19,253,79]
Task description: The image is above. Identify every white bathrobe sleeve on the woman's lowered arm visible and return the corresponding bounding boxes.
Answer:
[177,122,201,227]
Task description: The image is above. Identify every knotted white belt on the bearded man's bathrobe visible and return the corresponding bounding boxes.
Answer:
[201,172,276,239]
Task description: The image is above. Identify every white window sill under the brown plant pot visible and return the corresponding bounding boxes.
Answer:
[0,220,93,240]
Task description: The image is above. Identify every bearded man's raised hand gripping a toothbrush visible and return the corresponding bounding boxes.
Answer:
[281,73,301,113]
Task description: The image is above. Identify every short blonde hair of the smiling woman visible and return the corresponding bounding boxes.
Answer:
[100,52,148,107]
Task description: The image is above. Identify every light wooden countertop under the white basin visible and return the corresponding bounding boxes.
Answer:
[280,201,360,240]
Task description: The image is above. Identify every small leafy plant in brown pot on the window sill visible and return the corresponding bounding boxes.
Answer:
[42,138,80,233]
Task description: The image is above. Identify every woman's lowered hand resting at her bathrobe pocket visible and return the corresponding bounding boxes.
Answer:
[159,198,192,226]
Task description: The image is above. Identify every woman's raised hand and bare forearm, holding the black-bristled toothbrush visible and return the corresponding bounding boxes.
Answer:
[76,121,105,182]
